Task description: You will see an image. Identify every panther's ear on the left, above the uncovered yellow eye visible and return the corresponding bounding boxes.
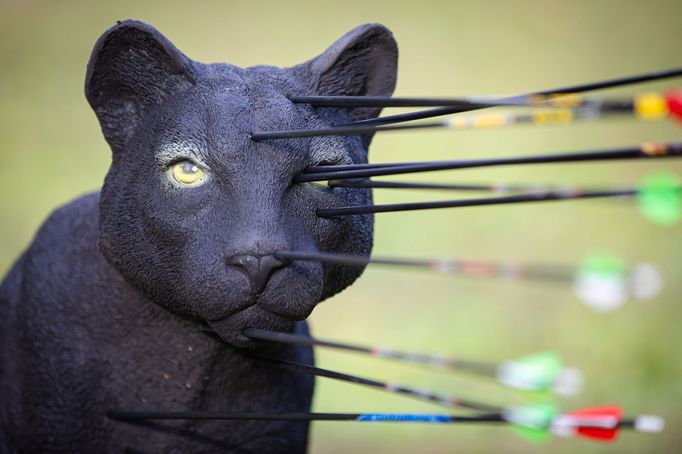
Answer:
[85,20,195,151]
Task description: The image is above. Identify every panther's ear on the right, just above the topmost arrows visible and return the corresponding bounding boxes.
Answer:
[294,24,398,120]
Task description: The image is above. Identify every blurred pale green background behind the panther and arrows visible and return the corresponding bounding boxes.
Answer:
[0,0,682,453]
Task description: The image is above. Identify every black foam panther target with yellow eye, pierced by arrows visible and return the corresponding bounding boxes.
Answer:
[0,20,397,453]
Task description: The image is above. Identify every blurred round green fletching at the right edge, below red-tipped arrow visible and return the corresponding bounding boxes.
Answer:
[637,173,682,225]
